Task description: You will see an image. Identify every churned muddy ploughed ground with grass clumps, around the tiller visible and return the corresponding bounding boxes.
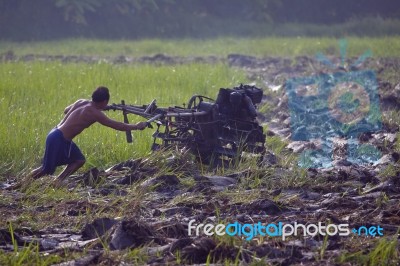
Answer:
[0,53,400,265]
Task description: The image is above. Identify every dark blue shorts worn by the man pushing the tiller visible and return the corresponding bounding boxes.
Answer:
[42,128,85,175]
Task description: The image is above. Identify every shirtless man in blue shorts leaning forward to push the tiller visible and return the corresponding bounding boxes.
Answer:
[31,87,147,180]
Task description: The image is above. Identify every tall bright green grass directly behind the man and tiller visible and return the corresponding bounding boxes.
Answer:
[0,62,247,176]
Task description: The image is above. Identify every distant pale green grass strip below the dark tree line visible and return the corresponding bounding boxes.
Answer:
[0,36,400,57]
